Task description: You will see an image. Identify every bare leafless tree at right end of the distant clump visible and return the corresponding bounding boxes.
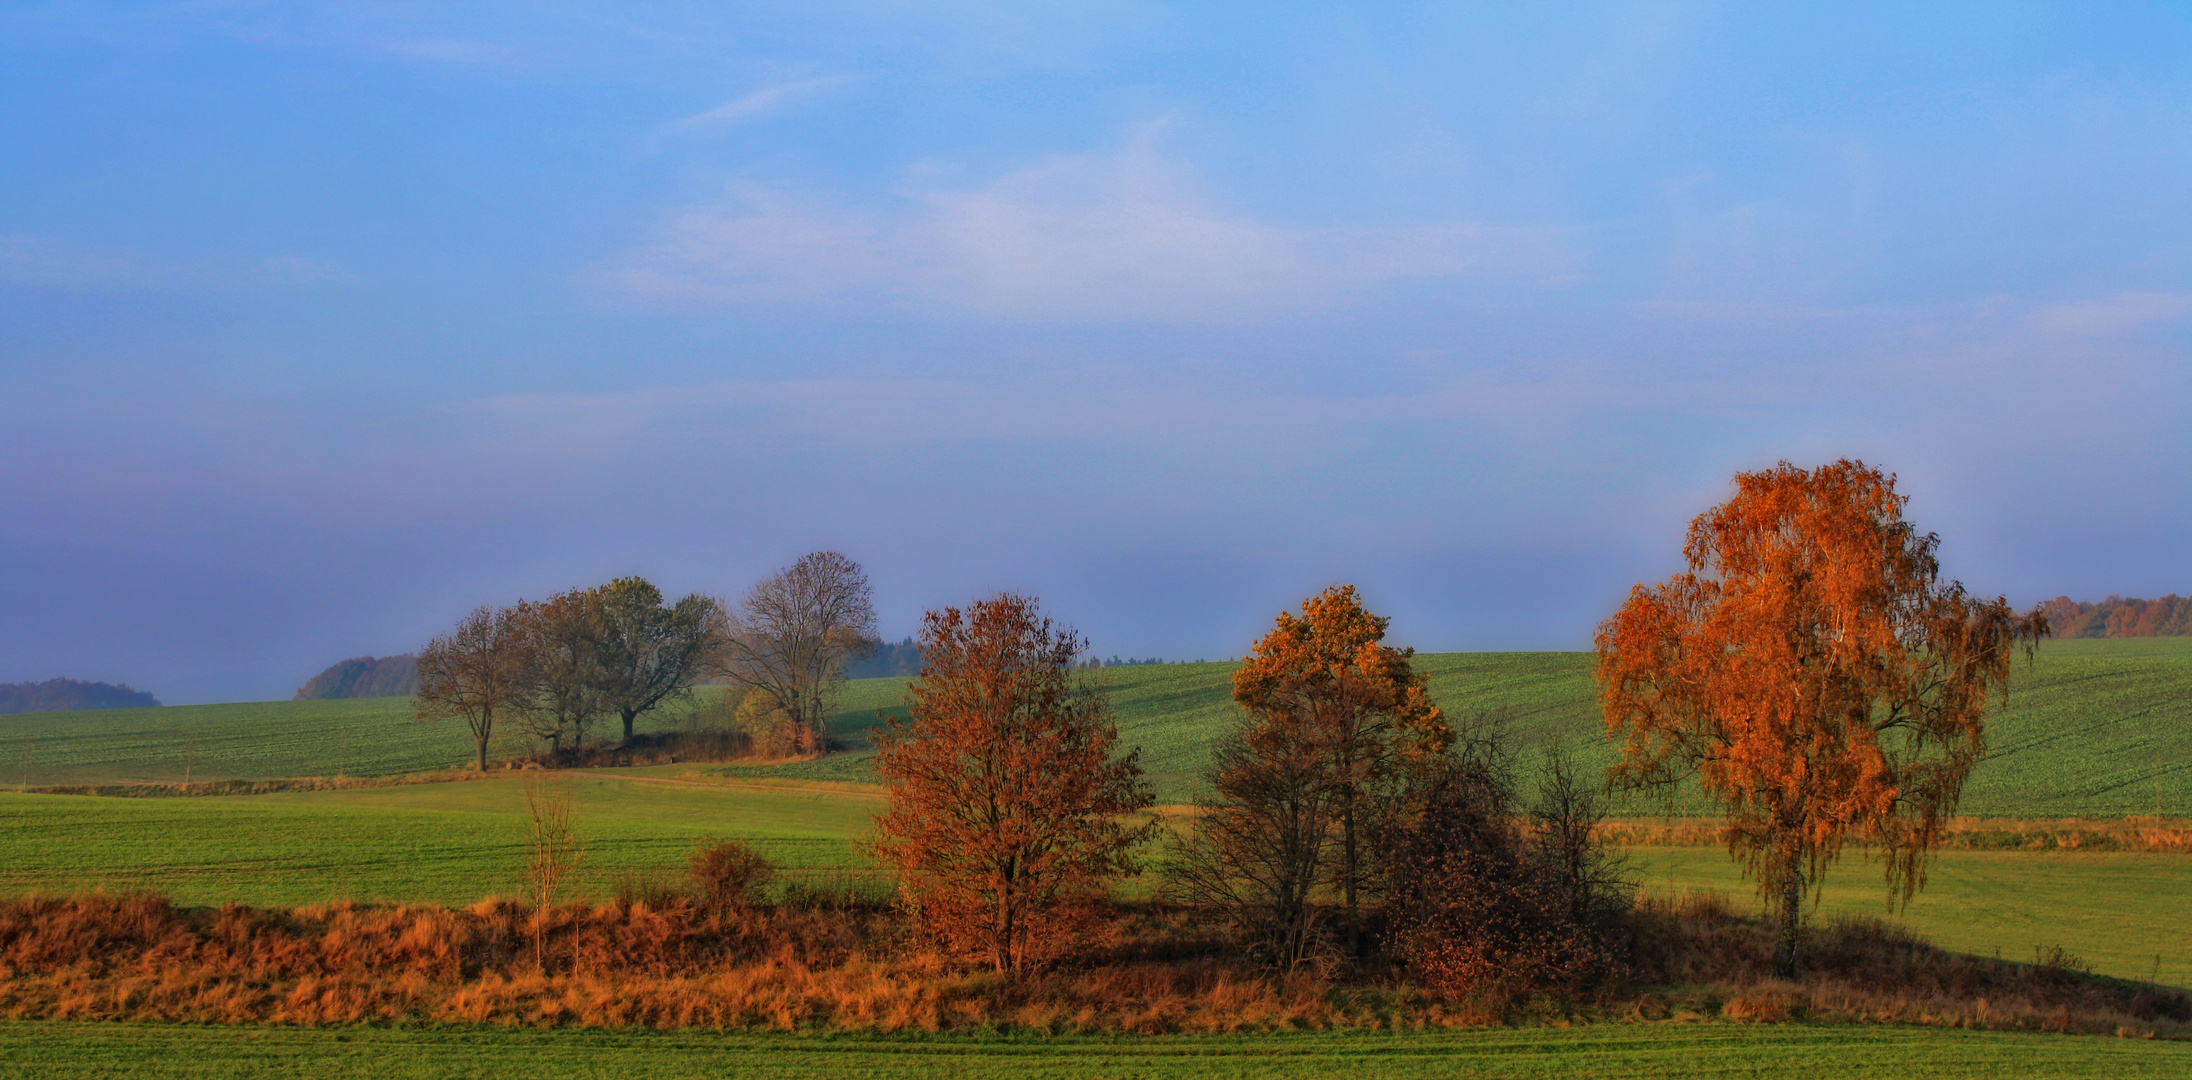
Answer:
[717,552,877,749]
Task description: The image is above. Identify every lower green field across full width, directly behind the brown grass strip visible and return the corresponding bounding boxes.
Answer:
[0,767,2192,986]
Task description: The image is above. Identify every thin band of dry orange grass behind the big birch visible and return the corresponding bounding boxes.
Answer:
[1598,817,2192,854]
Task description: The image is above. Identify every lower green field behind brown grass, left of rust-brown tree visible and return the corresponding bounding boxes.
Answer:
[0,769,881,907]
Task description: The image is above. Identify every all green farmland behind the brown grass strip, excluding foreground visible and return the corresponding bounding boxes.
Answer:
[0,640,2192,986]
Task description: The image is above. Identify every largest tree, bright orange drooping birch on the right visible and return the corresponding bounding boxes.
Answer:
[1596,460,2047,977]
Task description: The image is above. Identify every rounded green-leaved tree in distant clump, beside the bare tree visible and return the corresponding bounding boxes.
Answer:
[592,578,721,745]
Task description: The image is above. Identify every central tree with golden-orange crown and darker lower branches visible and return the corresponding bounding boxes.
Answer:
[1181,585,1453,964]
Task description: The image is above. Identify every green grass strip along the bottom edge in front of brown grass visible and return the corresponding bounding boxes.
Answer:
[0,1021,2192,1080]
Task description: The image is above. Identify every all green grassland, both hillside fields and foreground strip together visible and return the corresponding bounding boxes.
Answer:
[0,640,2192,1051]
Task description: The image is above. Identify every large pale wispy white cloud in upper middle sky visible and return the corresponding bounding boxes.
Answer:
[581,127,1578,322]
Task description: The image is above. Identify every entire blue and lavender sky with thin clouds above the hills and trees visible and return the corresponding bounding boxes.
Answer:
[0,0,2192,703]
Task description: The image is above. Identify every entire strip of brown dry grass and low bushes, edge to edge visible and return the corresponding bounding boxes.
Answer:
[0,892,2192,1038]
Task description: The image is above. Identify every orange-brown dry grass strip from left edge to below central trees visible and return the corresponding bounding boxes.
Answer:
[0,894,1440,1032]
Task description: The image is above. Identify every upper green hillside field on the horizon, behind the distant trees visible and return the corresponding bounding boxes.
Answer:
[0,637,2192,817]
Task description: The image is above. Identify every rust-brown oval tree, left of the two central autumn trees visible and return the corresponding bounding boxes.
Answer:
[875,594,1153,975]
